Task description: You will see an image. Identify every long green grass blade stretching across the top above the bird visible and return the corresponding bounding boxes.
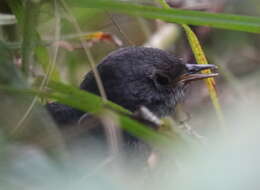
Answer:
[67,0,260,33]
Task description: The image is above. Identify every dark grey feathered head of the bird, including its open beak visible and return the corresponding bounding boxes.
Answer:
[80,47,217,117]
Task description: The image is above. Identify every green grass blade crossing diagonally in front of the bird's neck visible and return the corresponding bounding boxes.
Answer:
[0,81,186,147]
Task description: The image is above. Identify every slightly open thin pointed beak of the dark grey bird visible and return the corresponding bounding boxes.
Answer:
[179,64,218,83]
